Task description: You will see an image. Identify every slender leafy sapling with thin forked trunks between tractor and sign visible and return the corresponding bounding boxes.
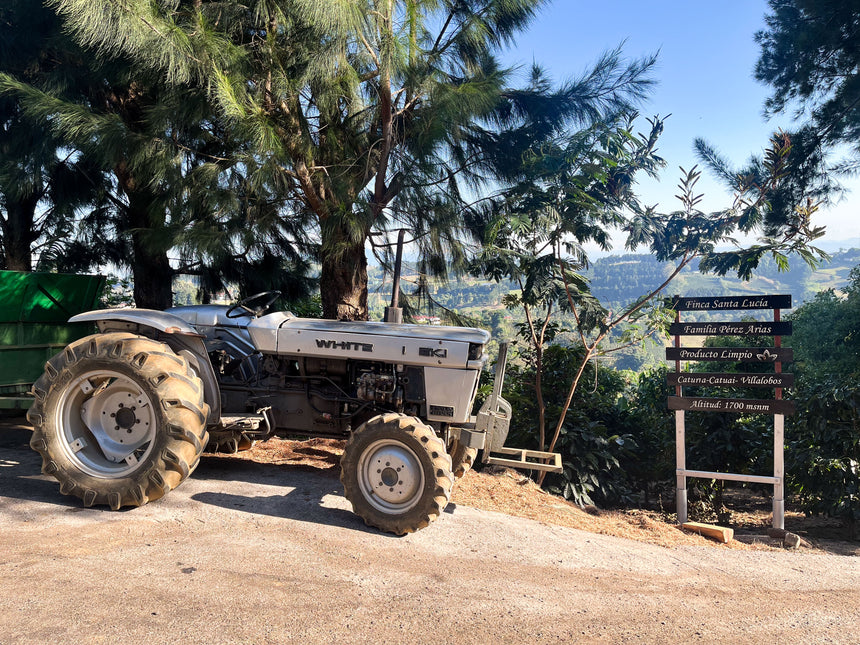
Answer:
[480,118,824,490]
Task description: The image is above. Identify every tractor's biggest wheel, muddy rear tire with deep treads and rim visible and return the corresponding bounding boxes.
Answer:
[27,333,208,510]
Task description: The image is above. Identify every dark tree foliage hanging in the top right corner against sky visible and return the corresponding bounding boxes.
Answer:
[755,0,860,169]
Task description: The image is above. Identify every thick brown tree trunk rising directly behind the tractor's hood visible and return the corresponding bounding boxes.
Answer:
[320,244,368,320]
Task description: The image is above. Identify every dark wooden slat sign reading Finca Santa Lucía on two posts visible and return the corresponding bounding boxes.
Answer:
[666,295,794,529]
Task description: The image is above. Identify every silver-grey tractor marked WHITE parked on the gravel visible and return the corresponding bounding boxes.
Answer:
[27,292,560,535]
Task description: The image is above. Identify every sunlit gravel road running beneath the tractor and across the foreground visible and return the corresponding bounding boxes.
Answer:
[0,420,860,645]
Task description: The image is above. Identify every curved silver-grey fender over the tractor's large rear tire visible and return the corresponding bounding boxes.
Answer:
[69,308,221,425]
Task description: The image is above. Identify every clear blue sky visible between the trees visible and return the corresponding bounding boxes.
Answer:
[498,0,860,247]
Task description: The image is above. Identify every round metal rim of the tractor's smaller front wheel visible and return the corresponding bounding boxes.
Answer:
[358,439,424,513]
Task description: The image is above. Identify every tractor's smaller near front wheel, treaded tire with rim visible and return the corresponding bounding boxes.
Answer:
[341,413,454,535]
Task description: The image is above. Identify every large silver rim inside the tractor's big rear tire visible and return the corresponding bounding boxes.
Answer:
[58,370,157,479]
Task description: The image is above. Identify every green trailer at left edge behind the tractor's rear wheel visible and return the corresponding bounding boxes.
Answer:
[0,271,105,408]
